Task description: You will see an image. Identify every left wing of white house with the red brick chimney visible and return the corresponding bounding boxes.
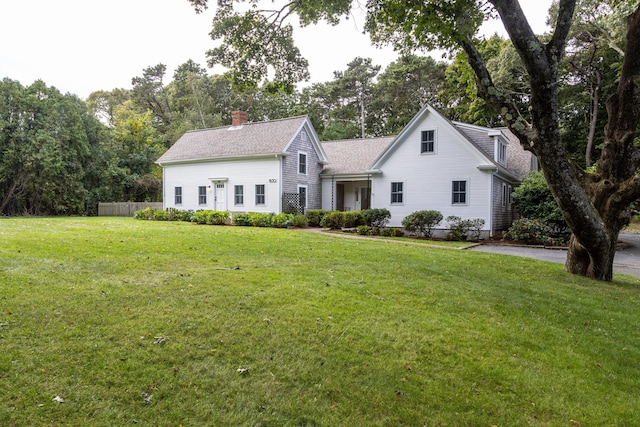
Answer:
[156,111,327,213]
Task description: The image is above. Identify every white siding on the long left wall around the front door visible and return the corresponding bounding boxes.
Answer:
[163,158,281,213]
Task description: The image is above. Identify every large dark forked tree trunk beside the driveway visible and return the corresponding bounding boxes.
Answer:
[482,0,640,281]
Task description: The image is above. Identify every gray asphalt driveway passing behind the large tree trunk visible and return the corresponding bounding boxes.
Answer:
[469,233,640,277]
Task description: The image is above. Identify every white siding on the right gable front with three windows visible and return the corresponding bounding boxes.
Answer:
[372,114,492,229]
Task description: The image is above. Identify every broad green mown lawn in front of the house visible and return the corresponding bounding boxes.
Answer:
[0,218,640,427]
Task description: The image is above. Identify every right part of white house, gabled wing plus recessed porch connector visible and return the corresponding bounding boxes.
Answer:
[322,105,535,234]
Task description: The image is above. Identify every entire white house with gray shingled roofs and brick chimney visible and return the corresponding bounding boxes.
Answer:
[157,105,537,235]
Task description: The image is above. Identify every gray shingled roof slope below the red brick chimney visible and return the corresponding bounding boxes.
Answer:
[157,116,307,164]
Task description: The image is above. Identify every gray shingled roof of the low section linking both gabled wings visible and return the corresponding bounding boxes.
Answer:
[322,136,395,175]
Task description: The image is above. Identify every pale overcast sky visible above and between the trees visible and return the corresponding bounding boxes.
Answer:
[0,0,551,99]
